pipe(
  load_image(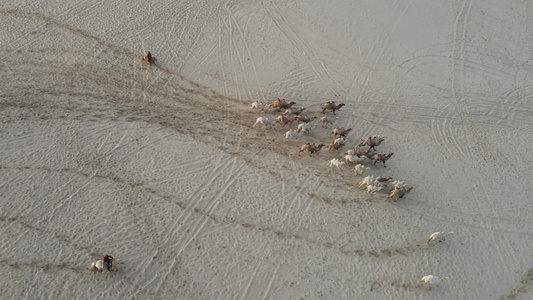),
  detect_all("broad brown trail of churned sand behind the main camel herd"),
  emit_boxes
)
[0,10,384,202]
